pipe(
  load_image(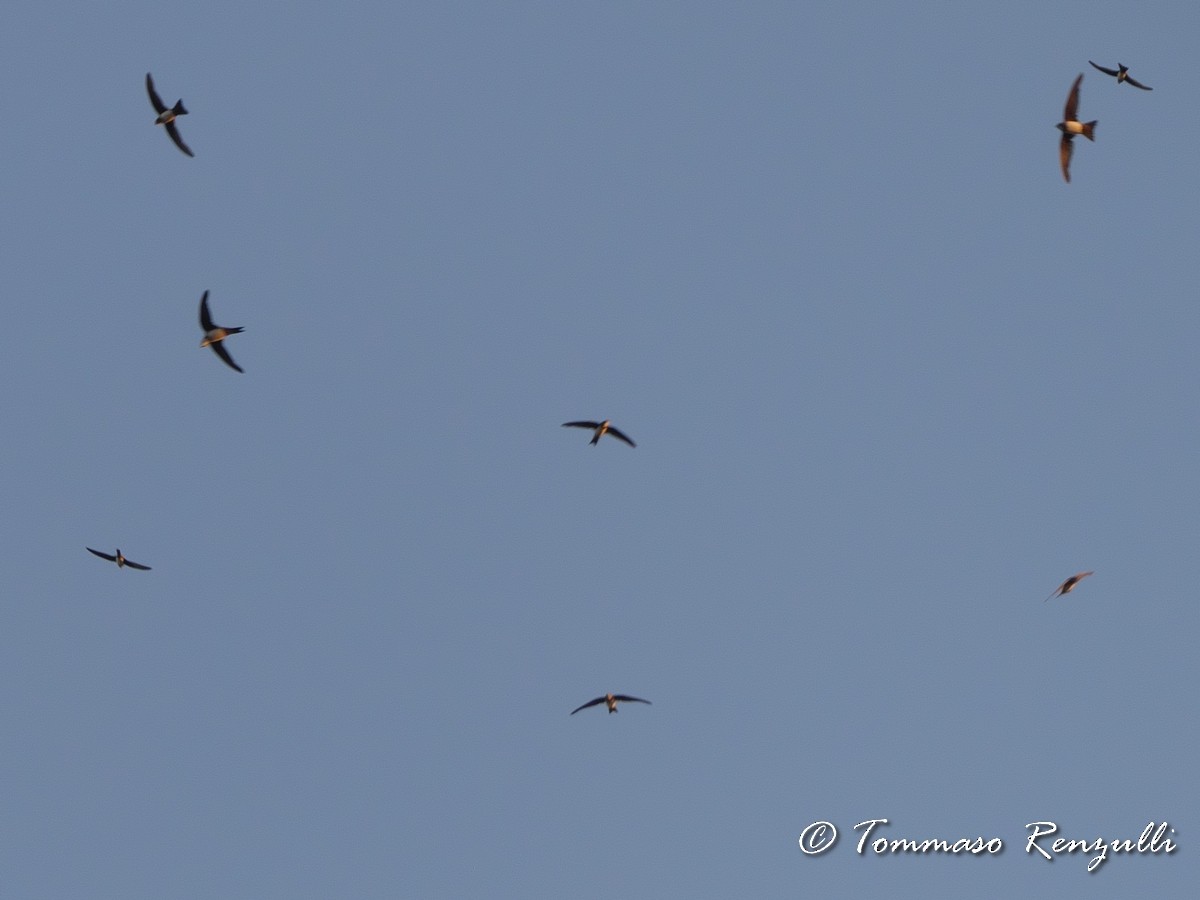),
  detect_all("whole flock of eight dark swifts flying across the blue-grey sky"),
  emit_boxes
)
[88,60,1132,715]
